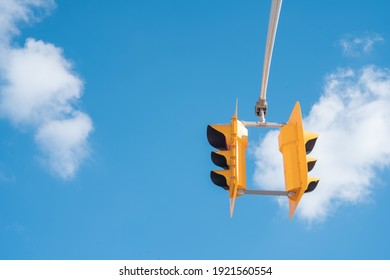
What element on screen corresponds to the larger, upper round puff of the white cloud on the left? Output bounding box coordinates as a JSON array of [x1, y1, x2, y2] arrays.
[[0, 38, 82, 124]]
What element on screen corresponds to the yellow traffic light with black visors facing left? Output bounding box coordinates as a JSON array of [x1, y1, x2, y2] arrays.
[[207, 113, 248, 216]]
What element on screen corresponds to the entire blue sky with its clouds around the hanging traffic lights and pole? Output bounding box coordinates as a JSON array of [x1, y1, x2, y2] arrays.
[[0, 0, 390, 259]]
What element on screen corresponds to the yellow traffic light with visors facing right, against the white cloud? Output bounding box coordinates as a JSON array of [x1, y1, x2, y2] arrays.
[[279, 102, 319, 219]]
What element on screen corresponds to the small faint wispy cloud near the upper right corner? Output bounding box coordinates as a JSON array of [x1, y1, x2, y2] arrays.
[[337, 34, 383, 57]]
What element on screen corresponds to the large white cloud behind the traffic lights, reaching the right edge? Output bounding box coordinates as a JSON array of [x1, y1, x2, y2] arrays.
[[254, 66, 390, 222]]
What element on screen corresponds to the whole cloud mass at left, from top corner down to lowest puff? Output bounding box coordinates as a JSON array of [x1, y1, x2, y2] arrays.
[[0, 0, 93, 179]]
